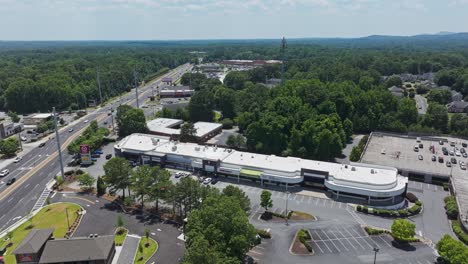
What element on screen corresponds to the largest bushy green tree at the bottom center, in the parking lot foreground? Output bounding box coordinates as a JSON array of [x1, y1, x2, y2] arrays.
[[186, 194, 256, 263]]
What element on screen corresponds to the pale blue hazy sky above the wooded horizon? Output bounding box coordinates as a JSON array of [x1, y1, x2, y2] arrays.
[[0, 0, 468, 40]]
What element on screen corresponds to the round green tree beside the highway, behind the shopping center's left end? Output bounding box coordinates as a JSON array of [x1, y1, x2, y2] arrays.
[[116, 105, 148, 137]]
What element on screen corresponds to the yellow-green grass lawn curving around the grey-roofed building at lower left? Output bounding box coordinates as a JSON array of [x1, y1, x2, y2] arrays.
[[0, 203, 81, 263]]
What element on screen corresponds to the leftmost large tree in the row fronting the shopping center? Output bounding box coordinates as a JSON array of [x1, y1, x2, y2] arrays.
[[103, 157, 132, 200]]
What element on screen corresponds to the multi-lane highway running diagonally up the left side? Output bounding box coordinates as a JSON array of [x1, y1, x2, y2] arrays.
[[0, 64, 192, 232]]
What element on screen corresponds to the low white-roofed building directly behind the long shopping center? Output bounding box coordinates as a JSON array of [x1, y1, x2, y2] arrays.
[[147, 118, 223, 142]]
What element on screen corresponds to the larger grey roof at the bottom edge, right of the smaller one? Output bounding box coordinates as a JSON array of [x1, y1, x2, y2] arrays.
[[39, 236, 114, 263]]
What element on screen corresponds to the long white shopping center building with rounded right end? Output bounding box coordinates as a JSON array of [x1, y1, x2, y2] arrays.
[[114, 134, 408, 206]]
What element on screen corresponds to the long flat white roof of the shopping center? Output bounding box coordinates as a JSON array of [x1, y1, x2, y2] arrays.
[[117, 134, 398, 188]]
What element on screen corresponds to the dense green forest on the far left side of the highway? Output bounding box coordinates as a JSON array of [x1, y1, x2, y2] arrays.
[[0, 46, 190, 114]]
